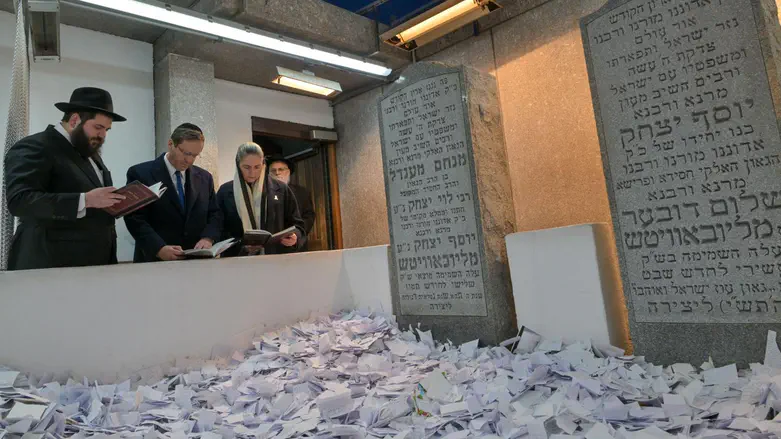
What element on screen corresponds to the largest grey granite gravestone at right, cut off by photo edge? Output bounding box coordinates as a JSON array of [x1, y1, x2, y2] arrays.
[[581, 0, 781, 364]]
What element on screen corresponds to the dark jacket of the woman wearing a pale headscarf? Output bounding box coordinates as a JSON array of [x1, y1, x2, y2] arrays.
[[217, 178, 306, 256]]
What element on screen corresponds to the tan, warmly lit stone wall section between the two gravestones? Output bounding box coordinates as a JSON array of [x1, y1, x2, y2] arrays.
[[493, 0, 610, 231]]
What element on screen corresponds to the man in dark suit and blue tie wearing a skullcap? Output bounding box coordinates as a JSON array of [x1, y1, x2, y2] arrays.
[[125, 123, 222, 262]]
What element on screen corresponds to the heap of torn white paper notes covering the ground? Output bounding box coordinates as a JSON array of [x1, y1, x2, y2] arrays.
[[0, 312, 781, 439]]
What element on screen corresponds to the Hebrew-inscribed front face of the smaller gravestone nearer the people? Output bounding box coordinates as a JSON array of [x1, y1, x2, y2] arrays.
[[380, 73, 486, 316]]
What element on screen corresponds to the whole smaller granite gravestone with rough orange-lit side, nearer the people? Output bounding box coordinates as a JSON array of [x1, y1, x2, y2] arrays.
[[379, 63, 516, 343]]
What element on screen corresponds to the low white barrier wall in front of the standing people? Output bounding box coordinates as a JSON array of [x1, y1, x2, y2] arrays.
[[0, 246, 391, 382]]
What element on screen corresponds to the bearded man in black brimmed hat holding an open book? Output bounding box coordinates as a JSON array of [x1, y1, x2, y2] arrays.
[[5, 87, 126, 270]]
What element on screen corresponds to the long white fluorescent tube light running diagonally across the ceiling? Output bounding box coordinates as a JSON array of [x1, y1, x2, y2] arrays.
[[70, 0, 392, 76]]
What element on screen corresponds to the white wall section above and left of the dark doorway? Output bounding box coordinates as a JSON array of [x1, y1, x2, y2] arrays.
[[214, 79, 334, 184]]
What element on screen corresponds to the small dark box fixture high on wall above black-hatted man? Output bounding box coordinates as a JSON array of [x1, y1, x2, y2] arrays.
[[27, 0, 60, 61]]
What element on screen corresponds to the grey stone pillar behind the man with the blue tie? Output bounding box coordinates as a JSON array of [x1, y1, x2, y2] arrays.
[[154, 54, 218, 182]]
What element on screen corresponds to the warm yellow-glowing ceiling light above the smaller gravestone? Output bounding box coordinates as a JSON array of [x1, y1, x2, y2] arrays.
[[380, 0, 500, 50]]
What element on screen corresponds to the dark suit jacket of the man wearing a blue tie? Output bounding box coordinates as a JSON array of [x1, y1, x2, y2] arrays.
[[125, 154, 222, 262]]
